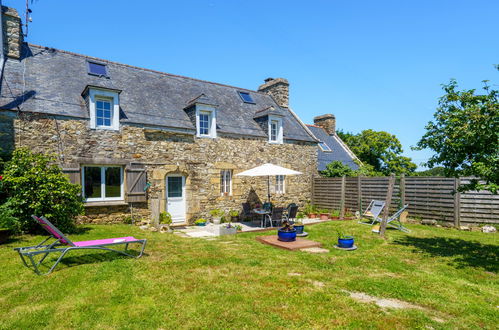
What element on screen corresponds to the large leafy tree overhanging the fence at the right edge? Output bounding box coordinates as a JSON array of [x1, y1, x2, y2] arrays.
[[415, 75, 499, 194]]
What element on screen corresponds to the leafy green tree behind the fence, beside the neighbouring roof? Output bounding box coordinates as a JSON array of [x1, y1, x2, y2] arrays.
[[337, 129, 417, 175]]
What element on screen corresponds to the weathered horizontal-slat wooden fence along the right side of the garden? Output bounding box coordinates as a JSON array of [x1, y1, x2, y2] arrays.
[[312, 176, 499, 226]]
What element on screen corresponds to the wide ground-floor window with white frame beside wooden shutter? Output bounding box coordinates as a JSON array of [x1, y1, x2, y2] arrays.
[[81, 165, 124, 202]]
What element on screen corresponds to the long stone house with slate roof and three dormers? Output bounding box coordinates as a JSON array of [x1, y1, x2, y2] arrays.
[[0, 7, 317, 224]]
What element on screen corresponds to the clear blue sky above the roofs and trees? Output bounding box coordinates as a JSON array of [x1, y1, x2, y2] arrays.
[[3, 0, 499, 164]]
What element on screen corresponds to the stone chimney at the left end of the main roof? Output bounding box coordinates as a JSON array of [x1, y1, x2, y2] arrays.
[[2, 6, 23, 59]]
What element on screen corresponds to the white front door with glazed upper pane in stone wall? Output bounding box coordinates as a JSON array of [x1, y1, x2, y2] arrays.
[[166, 175, 185, 223]]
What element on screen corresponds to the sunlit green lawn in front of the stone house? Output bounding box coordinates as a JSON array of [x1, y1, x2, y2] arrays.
[[0, 221, 499, 329]]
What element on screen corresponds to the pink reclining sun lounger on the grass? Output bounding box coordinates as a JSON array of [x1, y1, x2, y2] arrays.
[[14, 215, 147, 275]]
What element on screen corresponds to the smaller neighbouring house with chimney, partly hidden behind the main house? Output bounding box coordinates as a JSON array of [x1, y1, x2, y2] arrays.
[[307, 114, 362, 171]]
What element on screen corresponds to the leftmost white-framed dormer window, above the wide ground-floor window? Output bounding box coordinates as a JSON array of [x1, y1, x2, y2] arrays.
[[88, 88, 120, 130]]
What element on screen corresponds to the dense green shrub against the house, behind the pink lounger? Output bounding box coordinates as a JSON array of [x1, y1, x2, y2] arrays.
[[2, 148, 84, 232]]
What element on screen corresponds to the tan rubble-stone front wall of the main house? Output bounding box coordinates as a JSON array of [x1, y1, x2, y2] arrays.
[[3, 111, 317, 222]]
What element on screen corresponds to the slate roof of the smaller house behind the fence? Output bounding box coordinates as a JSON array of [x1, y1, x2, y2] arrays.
[[307, 125, 359, 171]]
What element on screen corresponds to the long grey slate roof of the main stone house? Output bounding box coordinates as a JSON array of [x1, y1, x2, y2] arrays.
[[0, 44, 315, 142]]
